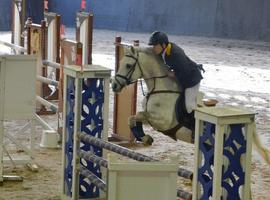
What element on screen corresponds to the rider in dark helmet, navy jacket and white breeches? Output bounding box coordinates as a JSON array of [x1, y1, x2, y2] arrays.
[[148, 31, 204, 136]]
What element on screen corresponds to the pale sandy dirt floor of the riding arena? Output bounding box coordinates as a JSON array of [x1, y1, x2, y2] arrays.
[[0, 29, 270, 200]]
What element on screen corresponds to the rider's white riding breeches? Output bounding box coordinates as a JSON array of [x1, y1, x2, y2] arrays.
[[185, 83, 200, 113]]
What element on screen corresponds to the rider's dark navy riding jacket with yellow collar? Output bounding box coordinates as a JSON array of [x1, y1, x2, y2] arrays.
[[164, 43, 203, 89]]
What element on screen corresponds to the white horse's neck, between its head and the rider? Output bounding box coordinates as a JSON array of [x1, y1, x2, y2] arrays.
[[141, 51, 180, 92]]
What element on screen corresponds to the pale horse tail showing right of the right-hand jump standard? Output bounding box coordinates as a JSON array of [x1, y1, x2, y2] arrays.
[[253, 126, 270, 165]]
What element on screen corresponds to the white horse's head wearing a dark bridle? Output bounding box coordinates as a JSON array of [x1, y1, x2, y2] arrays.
[[111, 46, 142, 92]]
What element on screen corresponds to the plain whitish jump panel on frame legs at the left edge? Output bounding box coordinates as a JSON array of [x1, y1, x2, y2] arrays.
[[0, 55, 37, 184]]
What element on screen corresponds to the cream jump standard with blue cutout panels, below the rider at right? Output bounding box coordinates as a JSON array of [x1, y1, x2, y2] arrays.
[[193, 107, 255, 200]]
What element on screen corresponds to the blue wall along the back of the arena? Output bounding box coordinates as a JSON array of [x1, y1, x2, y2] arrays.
[[0, 0, 270, 41]]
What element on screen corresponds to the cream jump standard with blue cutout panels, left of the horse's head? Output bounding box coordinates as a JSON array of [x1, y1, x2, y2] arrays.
[[61, 65, 111, 200]]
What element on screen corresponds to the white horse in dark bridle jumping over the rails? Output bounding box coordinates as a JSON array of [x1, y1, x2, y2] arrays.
[[112, 46, 270, 165]]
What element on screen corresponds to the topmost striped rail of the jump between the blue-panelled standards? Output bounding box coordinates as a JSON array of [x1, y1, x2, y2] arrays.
[[78, 133, 193, 180]]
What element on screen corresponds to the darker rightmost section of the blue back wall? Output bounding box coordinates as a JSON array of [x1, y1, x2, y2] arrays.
[[214, 0, 270, 41]]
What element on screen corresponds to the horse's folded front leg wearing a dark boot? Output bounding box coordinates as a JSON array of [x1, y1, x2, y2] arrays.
[[129, 112, 154, 145]]
